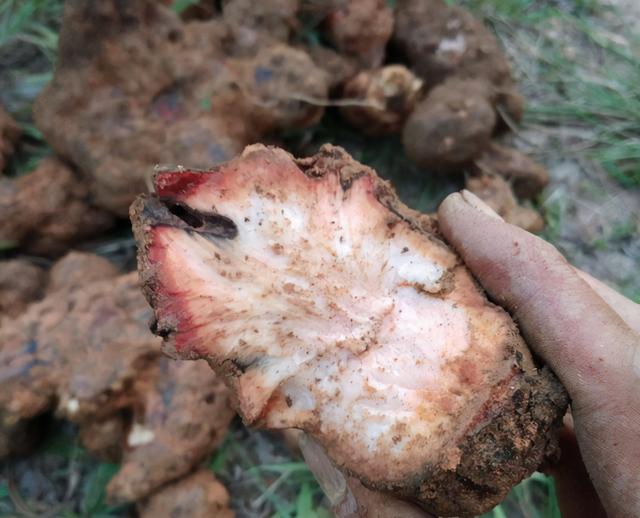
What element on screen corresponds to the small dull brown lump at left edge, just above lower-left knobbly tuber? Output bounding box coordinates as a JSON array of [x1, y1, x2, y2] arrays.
[[0, 259, 47, 318]]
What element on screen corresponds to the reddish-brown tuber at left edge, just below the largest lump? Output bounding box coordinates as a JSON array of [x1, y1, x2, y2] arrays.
[[0, 158, 113, 256]]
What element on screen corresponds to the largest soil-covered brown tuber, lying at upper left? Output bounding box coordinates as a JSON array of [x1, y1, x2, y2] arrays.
[[35, 0, 327, 215]]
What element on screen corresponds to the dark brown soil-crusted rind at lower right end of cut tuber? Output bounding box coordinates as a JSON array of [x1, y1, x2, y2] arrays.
[[363, 366, 569, 518]]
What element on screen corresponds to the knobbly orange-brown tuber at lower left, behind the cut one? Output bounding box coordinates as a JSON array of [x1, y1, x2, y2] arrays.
[[0, 272, 233, 500]]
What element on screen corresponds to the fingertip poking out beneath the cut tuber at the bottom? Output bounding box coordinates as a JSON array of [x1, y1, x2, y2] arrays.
[[299, 434, 432, 518]]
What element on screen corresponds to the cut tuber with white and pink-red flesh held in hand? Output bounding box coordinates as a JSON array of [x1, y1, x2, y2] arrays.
[[131, 145, 567, 516]]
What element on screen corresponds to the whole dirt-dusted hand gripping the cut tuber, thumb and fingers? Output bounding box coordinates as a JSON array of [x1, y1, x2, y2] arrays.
[[301, 191, 640, 518]]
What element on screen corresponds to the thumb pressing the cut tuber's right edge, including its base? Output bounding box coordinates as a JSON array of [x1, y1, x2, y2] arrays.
[[438, 191, 640, 516]]
